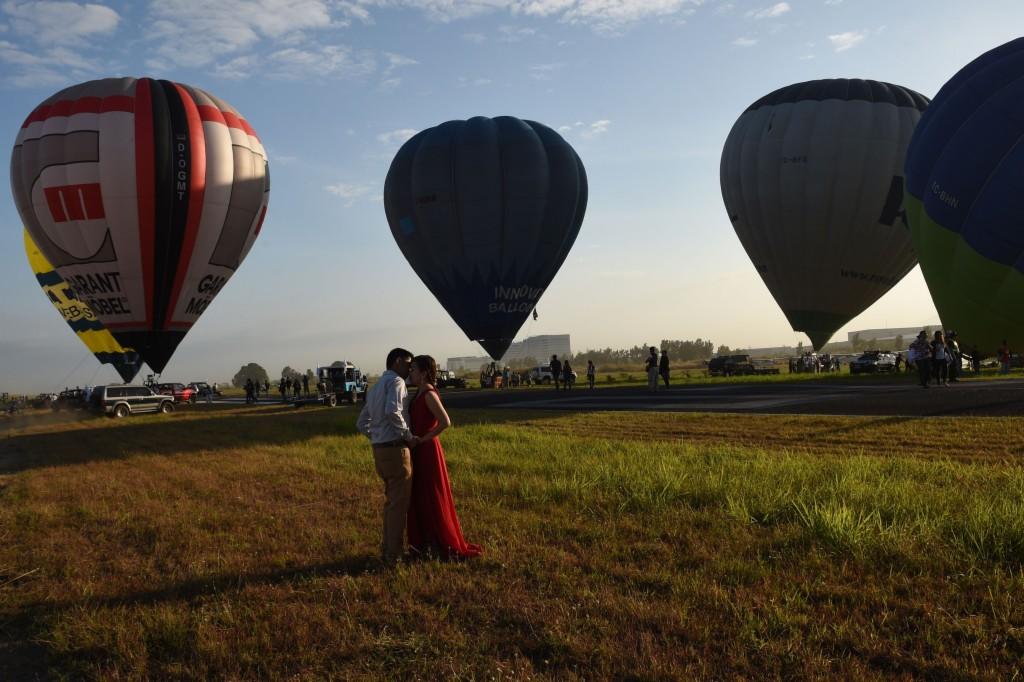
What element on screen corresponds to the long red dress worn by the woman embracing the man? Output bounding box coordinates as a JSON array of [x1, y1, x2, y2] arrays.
[[408, 388, 482, 558]]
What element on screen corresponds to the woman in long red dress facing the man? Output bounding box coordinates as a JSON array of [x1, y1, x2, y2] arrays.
[[408, 355, 481, 559]]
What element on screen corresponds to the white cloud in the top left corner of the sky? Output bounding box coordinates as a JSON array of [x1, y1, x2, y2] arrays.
[[3, 1, 121, 45]]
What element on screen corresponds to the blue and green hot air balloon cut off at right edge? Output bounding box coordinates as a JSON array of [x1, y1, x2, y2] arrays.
[[906, 38, 1024, 353]]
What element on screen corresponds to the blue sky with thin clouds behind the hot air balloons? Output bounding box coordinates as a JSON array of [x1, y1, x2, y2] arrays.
[[0, 0, 1024, 392]]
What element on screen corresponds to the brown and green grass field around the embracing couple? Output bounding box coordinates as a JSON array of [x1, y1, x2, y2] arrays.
[[0, 406, 1024, 680]]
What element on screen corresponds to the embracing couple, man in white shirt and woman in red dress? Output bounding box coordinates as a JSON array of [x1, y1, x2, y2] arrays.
[[356, 348, 481, 566]]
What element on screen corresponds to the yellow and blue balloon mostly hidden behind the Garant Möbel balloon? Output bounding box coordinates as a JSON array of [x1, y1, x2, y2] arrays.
[[23, 229, 141, 383]]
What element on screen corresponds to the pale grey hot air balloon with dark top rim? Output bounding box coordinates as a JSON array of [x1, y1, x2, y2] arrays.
[[721, 79, 928, 348]]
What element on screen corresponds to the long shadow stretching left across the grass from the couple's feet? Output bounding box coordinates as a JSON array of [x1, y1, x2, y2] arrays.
[[0, 555, 387, 680]]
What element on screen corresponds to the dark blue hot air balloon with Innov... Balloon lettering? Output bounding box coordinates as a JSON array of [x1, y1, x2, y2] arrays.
[[384, 116, 587, 359]]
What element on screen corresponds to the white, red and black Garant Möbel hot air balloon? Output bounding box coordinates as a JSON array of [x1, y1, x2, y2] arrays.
[[10, 78, 269, 373]]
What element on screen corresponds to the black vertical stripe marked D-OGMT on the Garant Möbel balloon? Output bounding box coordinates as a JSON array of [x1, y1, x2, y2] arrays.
[[152, 81, 191, 330]]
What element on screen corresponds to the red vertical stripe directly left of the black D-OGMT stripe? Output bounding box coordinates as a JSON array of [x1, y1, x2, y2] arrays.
[[135, 78, 157, 329]]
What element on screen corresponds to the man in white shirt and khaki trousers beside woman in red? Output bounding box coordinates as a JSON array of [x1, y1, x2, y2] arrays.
[[355, 348, 420, 566]]
